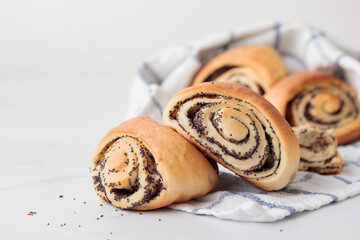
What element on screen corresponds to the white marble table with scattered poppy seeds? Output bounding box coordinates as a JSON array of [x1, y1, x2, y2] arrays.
[[0, 76, 360, 240]]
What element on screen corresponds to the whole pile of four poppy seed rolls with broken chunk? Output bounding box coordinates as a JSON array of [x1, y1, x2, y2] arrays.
[[90, 45, 360, 210]]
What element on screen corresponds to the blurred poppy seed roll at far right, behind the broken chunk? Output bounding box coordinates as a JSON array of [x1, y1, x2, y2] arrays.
[[264, 71, 360, 144]]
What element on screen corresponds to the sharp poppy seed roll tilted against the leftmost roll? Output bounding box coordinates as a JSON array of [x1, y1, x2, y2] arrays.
[[163, 83, 300, 190]]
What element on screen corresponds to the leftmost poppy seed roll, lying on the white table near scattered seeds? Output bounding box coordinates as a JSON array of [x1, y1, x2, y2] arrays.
[[90, 117, 219, 210]]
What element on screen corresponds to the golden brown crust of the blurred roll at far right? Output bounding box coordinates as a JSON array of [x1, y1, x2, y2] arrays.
[[264, 71, 360, 145]]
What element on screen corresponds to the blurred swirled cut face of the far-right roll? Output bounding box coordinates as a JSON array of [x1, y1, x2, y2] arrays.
[[286, 83, 359, 129]]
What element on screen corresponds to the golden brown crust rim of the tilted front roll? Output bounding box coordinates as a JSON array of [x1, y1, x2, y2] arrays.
[[163, 83, 300, 190]]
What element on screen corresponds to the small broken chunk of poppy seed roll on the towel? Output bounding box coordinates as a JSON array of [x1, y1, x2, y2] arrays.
[[293, 125, 343, 174]]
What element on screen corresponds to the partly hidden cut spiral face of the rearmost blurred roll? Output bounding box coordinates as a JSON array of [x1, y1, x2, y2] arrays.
[[204, 65, 265, 95]]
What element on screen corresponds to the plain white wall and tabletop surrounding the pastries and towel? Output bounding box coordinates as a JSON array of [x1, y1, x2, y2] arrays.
[[0, 0, 360, 239]]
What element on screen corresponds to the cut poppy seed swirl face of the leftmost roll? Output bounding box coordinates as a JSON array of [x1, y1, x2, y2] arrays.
[[92, 134, 163, 209]]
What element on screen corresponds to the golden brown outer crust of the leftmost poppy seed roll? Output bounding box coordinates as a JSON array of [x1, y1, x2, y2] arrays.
[[90, 117, 219, 210]]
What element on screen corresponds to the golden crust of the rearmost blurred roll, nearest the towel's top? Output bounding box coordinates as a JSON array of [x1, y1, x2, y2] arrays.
[[192, 45, 287, 90]]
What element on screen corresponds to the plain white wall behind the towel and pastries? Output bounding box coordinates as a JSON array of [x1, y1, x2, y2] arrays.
[[0, 0, 360, 78]]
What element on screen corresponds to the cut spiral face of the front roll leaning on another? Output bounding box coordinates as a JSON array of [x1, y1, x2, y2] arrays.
[[169, 92, 281, 178]]
